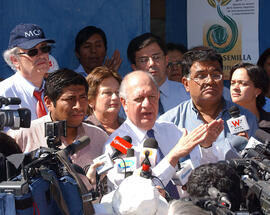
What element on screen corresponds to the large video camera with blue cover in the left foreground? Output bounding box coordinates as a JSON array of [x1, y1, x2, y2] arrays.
[[0, 121, 95, 215]]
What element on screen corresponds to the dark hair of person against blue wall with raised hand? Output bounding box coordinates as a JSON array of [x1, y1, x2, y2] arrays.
[[75, 26, 107, 53]]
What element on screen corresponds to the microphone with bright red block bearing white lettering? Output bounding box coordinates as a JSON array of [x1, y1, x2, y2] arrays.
[[110, 136, 132, 159]]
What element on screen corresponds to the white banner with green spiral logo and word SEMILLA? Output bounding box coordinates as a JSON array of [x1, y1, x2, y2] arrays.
[[187, 0, 259, 79]]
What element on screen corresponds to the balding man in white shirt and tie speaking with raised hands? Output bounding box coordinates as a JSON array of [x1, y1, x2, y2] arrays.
[[105, 71, 223, 198]]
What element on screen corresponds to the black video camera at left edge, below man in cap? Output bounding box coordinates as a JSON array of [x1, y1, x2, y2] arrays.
[[0, 96, 31, 130]]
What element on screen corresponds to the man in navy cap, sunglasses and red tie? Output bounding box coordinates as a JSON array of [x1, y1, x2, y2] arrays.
[[0, 24, 55, 120]]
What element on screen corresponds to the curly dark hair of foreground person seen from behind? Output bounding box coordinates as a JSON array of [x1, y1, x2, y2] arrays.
[[187, 161, 241, 210]]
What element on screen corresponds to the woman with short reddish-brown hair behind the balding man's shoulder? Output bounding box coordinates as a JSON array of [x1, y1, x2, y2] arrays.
[[85, 66, 124, 135]]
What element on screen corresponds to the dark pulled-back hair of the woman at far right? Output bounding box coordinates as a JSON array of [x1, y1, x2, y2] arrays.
[[230, 62, 269, 109]]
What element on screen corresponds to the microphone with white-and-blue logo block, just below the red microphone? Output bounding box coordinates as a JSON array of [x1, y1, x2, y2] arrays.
[[117, 148, 137, 178]]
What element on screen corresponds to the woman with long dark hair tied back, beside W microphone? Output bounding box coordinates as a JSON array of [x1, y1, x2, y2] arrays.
[[230, 63, 270, 133]]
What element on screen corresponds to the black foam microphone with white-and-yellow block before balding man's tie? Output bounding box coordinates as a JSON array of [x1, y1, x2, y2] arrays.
[[140, 138, 158, 167]]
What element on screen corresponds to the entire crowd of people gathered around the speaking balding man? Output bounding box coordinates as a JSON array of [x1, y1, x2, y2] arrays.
[[0, 24, 270, 215]]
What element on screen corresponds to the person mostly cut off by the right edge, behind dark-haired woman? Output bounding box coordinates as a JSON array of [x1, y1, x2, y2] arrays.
[[257, 48, 270, 112]]
